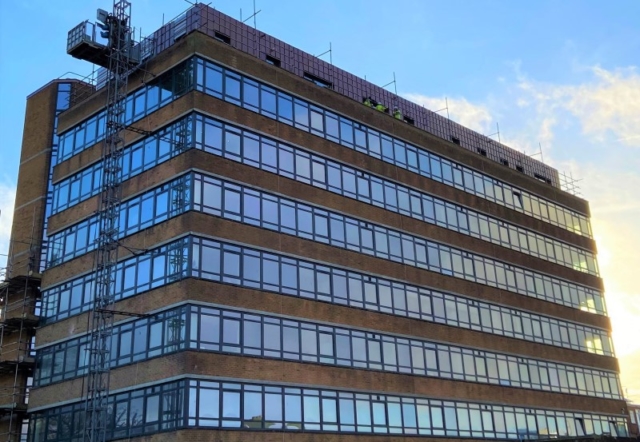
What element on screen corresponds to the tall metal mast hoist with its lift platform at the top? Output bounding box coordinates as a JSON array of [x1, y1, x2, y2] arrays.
[[67, 0, 142, 442]]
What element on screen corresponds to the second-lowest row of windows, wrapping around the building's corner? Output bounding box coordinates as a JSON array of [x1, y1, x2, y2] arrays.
[[35, 306, 620, 402]]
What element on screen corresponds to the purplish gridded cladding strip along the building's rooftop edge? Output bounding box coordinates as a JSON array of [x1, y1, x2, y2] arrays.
[[94, 3, 560, 188]]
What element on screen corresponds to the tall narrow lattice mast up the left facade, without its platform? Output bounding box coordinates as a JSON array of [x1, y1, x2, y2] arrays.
[[85, 0, 131, 442]]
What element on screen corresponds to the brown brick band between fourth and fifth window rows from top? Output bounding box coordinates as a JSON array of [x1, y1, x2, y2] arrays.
[[38, 270, 618, 371]]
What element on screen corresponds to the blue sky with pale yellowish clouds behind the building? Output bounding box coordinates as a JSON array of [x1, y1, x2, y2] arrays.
[[0, 0, 640, 403]]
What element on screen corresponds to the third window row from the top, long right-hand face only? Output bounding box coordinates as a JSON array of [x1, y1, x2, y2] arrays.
[[195, 175, 600, 314]]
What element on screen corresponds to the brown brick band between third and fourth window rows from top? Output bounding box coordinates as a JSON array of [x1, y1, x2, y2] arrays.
[[42, 212, 609, 340]]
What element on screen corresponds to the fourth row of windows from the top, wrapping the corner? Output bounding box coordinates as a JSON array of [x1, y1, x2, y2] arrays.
[[44, 228, 618, 370]]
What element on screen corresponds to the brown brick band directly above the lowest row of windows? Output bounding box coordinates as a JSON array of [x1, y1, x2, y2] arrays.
[[29, 351, 624, 413]]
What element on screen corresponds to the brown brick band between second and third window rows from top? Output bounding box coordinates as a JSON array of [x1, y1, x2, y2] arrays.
[[49, 149, 602, 290]]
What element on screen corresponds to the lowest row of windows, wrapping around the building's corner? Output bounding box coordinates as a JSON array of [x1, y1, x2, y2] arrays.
[[29, 380, 627, 442]]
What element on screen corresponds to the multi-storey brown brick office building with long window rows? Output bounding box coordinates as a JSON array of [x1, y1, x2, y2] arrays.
[[1, 4, 629, 442]]
